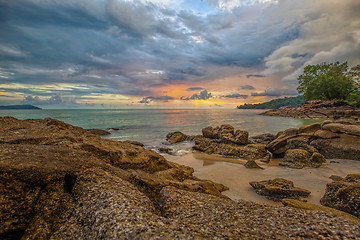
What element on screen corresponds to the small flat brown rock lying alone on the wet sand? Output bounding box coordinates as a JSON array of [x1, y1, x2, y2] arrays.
[[249, 178, 311, 201]]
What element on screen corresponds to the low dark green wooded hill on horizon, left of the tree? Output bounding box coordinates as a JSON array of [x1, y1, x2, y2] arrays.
[[237, 96, 305, 109]]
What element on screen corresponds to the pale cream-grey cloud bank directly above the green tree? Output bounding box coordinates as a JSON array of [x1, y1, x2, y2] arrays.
[[263, 0, 360, 83]]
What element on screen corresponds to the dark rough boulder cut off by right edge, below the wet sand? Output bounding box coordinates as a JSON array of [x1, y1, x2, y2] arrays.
[[320, 174, 360, 218]]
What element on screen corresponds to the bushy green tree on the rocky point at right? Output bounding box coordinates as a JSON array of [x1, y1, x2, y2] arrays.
[[297, 62, 360, 100]]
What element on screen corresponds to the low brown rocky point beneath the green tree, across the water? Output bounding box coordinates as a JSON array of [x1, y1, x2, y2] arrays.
[[261, 100, 360, 120]]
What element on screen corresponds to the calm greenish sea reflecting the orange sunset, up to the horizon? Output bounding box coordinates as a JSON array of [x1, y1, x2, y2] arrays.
[[0, 109, 320, 148]]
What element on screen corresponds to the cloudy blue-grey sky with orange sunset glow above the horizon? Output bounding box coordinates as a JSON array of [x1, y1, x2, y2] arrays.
[[0, 0, 360, 108]]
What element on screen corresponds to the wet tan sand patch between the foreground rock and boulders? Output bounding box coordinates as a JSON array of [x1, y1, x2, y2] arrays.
[[165, 152, 360, 205]]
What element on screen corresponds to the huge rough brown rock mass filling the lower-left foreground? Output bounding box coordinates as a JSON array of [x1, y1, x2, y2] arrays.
[[0, 117, 360, 239]]
